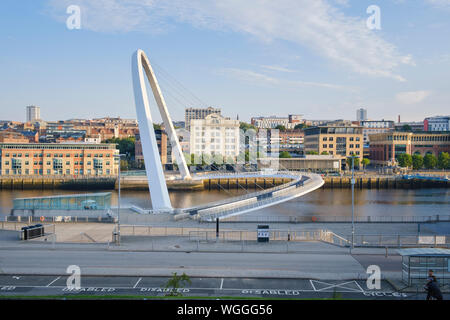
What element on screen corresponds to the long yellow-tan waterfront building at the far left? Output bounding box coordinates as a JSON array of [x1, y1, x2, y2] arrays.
[[0, 143, 119, 176]]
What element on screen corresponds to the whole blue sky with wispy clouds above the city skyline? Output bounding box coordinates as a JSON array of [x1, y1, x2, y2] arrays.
[[0, 0, 450, 121]]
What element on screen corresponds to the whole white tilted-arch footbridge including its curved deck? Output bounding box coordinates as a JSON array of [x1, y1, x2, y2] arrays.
[[131, 50, 324, 220]]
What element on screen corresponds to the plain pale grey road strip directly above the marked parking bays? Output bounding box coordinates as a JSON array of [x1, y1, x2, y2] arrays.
[[0, 248, 365, 280]]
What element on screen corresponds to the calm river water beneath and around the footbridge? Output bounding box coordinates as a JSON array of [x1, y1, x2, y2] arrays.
[[0, 189, 450, 216]]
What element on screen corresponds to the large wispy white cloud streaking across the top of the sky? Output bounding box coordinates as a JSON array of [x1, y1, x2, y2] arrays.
[[49, 0, 413, 81]]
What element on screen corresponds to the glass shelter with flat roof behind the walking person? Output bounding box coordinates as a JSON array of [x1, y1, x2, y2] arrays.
[[398, 248, 450, 286]]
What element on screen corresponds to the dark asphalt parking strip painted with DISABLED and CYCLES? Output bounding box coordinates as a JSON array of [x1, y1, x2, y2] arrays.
[[0, 274, 436, 300]]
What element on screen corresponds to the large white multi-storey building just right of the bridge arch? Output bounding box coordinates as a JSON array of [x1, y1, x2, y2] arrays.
[[190, 114, 239, 157]]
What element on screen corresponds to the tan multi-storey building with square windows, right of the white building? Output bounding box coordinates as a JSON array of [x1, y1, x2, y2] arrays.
[[304, 126, 363, 159]]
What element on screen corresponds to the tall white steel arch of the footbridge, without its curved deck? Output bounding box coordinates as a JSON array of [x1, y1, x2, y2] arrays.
[[131, 49, 191, 211]]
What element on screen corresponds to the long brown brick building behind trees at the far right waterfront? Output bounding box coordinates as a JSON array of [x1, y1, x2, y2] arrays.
[[369, 131, 450, 165]]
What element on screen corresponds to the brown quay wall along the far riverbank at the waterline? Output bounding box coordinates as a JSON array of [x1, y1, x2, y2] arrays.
[[0, 173, 450, 191]]
